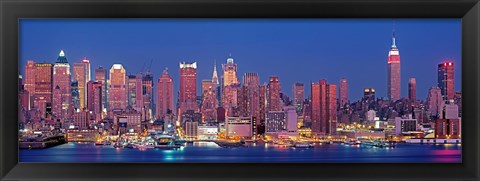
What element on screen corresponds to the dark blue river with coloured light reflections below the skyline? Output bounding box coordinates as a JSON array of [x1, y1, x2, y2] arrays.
[[19, 142, 462, 163]]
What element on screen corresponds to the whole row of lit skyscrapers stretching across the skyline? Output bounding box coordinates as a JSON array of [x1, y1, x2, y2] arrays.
[[20, 29, 461, 139]]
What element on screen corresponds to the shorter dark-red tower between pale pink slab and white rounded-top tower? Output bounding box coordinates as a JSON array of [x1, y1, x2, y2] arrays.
[[87, 81, 102, 122]]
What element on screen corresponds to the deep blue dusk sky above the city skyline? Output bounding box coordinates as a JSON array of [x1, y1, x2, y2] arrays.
[[20, 19, 461, 101]]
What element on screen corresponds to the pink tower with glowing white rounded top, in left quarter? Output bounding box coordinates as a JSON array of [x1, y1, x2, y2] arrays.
[[108, 64, 127, 111]]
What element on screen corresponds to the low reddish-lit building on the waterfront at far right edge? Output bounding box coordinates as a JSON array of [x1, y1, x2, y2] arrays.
[[435, 119, 461, 139]]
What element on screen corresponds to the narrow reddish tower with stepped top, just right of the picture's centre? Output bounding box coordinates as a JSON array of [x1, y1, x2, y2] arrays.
[[267, 76, 283, 111]]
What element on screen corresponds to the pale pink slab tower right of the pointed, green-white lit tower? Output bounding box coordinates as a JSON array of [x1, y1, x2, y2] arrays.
[[73, 57, 90, 109]]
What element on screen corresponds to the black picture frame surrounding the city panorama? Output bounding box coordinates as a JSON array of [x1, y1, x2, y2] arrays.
[[0, 0, 480, 180]]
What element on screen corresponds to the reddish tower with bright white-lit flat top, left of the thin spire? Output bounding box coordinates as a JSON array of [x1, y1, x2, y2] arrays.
[[178, 62, 198, 115]]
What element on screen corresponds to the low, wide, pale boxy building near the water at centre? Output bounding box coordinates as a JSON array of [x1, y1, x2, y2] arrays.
[[225, 117, 253, 139]]
